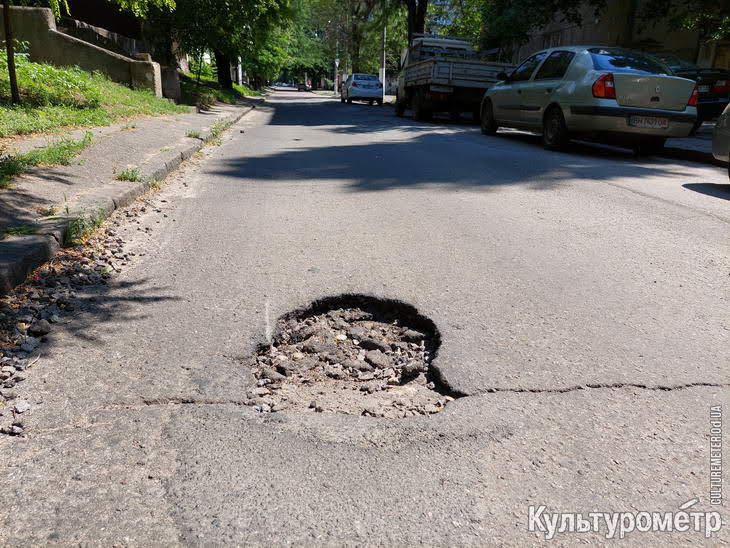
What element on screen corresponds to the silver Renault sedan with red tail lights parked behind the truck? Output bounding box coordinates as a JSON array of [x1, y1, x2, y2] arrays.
[[481, 46, 698, 153]]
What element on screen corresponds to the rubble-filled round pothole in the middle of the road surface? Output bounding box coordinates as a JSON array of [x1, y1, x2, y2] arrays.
[[247, 295, 454, 418]]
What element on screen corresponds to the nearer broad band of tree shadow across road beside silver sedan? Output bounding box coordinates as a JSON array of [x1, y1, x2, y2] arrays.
[[214, 124, 691, 192]]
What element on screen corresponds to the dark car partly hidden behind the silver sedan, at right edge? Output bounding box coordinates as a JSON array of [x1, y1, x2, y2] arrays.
[[653, 53, 730, 124]]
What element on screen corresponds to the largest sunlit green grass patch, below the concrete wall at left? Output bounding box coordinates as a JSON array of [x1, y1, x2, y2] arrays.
[[0, 53, 190, 137]]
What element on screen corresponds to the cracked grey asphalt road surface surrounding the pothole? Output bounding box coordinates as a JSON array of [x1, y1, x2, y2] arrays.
[[0, 92, 730, 545]]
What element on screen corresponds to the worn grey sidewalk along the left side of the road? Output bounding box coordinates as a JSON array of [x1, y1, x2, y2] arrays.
[[0, 99, 262, 295]]
